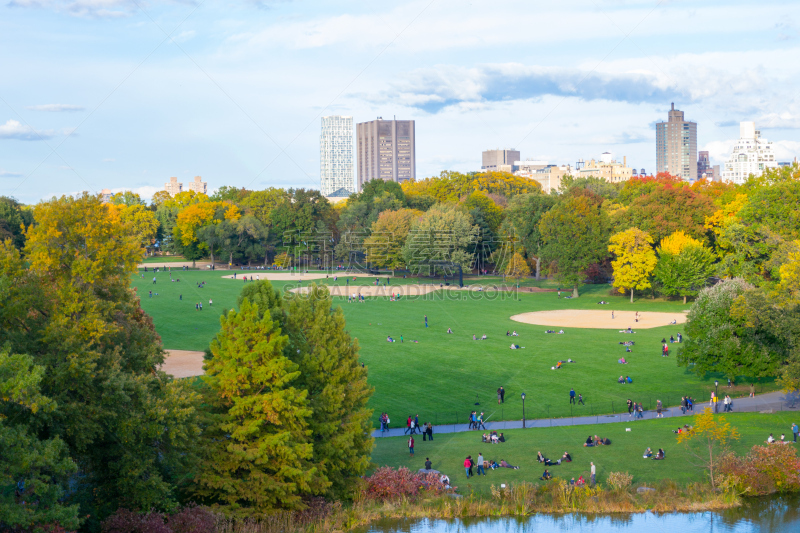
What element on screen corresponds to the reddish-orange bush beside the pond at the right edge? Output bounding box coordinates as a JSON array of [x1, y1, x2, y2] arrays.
[[719, 444, 800, 496]]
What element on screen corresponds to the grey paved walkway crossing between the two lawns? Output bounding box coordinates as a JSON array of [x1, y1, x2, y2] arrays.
[[372, 391, 800, 438]]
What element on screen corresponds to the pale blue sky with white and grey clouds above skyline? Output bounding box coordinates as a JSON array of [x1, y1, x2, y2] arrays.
[[0, 0, 800, 202]]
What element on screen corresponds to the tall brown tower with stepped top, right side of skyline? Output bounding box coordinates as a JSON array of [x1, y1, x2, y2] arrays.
[[656, 104, 697, 181]]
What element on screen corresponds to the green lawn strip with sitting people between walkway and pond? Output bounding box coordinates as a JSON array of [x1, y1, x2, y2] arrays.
[[372, 413, 800, 492]]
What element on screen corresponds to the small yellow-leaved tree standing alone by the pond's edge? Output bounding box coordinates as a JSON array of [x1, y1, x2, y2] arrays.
[[678, 407, 739, 487]]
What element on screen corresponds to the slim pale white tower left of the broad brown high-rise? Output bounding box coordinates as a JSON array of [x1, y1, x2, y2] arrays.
[[319, 115, 355, 196]]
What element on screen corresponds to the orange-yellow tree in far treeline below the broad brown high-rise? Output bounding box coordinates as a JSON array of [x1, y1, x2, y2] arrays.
[[364, 209, 422, 270]]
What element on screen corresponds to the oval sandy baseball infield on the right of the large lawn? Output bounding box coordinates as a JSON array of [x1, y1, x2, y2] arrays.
[[511, 309, 686, 331]]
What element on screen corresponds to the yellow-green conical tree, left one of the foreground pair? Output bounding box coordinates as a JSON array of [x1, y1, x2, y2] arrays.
[[192, 298, 318, 515]]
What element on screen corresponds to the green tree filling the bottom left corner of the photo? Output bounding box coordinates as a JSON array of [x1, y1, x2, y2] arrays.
[[0, 349, 80, 530]]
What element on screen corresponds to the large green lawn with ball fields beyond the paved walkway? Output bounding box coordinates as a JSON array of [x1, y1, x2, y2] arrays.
[[133, 269, 780, 427]]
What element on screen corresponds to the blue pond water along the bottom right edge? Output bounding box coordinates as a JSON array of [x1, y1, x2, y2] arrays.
[[359, 496, 800, 533]]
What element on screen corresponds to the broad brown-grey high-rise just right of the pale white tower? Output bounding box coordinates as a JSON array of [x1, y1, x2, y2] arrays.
[[356, 117, 417, 190]]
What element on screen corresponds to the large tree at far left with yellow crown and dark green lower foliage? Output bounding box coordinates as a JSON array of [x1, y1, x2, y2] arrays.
[[0, 194, 197, 520]]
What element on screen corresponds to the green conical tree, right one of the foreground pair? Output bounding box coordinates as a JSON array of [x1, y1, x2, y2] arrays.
[[286, 285, 373, 498]]
